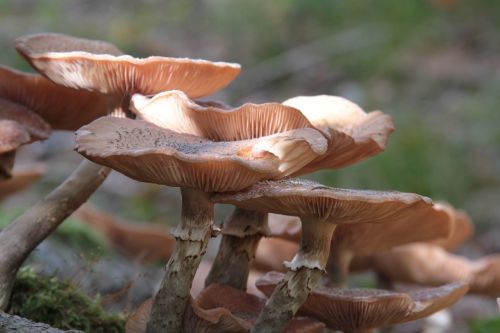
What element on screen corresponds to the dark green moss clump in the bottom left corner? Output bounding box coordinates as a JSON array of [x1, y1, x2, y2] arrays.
[[9, 267, 125, 333]]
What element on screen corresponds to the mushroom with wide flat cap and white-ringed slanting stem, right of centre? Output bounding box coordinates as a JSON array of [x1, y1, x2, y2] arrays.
[[213, 179, 444, 332]]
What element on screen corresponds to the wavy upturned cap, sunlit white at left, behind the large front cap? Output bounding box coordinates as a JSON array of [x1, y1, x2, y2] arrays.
[[131, 90, 313, 141]]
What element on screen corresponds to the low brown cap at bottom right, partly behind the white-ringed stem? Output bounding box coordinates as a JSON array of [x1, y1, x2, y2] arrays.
[[256, 272, 468, 333]]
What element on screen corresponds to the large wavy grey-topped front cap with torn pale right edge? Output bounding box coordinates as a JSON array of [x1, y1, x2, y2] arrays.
[[76, 117, 326, 192]]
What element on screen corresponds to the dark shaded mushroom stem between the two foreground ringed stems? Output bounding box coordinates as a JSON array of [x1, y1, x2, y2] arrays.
[[205, 207, 269, 290]]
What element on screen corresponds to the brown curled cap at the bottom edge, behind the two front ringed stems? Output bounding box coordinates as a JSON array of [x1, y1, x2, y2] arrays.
[[125, 284, 325, 333]]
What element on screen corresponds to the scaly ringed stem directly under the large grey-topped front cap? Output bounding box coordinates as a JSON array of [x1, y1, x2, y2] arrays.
[[147, 188, 214, 333]]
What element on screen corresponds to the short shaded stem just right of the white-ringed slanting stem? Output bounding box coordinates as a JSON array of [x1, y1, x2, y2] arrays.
[[324, 244, 354, 288]]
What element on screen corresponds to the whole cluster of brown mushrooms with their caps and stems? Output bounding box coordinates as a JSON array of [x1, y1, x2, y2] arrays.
[[0, 34, 494, 333]]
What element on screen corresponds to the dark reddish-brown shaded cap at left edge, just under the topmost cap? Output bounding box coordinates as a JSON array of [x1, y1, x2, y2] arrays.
[[0, 66, 108, 131]]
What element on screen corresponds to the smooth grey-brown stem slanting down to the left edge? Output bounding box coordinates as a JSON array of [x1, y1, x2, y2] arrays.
[[0, 160, 110, 310]]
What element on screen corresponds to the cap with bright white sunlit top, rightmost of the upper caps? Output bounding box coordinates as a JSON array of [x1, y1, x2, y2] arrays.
[[283, 95, 394, 176]]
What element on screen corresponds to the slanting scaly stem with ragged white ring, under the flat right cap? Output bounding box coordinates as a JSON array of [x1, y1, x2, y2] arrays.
[[250, 218, 335, 333]]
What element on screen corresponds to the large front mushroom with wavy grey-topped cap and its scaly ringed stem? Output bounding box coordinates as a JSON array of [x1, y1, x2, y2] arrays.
[[76, 113, 326, 331]]
